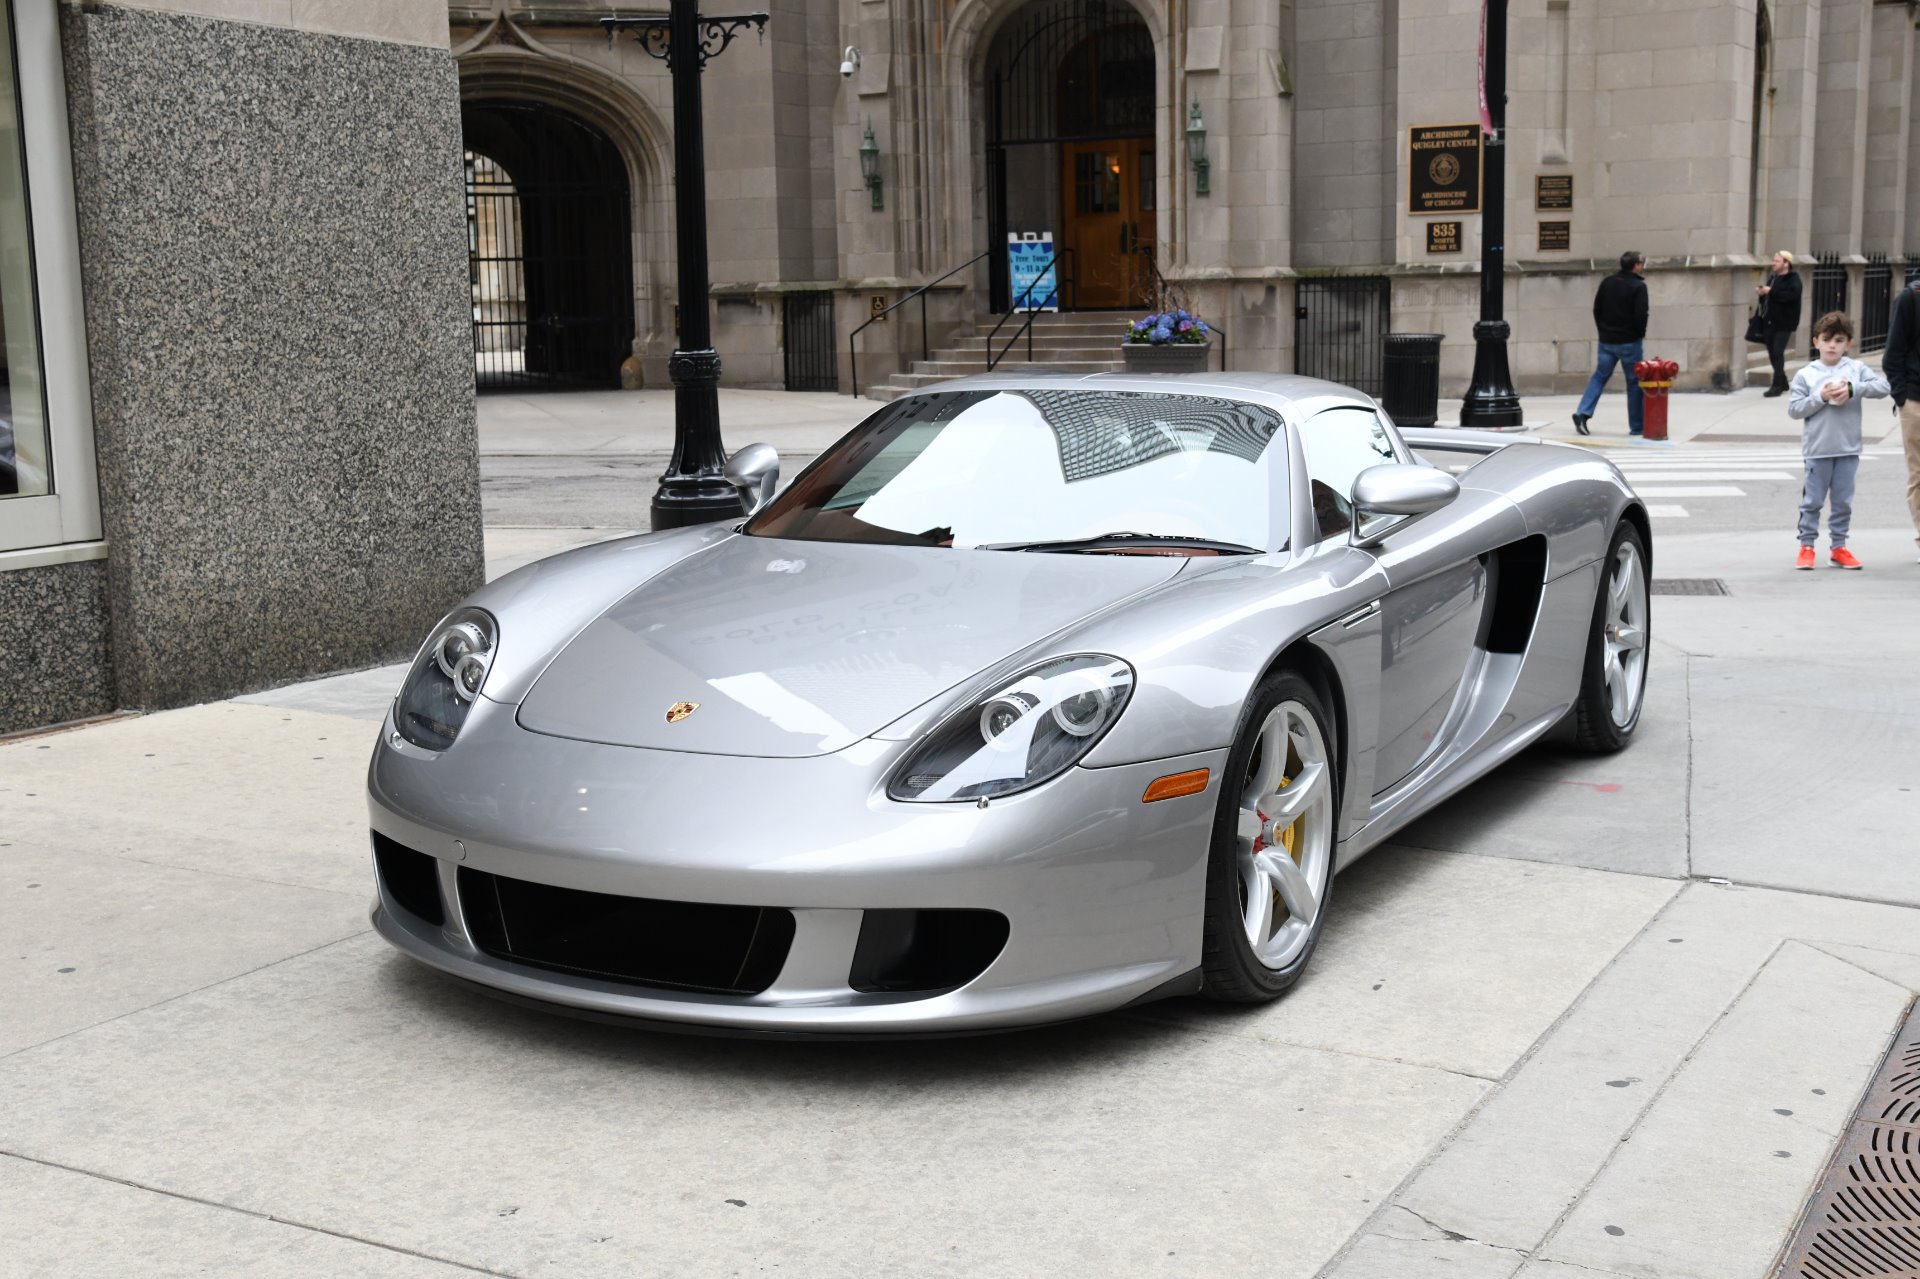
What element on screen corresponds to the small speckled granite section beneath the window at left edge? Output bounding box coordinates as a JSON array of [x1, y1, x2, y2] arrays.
[[0, 559, 113, 734]]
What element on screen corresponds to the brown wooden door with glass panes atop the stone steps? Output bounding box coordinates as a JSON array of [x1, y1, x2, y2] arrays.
[[1060, 138, 1158, 309]]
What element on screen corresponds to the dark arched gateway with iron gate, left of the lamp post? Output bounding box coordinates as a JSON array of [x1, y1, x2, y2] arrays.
[[461, 100, 634, 390]]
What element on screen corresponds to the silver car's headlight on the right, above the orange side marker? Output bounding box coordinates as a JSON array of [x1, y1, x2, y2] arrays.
[[887, 653, 1133, 803]]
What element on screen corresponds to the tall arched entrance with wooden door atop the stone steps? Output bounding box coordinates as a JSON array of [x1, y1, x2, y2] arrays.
[[987, 0, 1160, 311]]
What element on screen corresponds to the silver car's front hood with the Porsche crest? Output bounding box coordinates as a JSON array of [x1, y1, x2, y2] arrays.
[[518, 536, 1187, 757]]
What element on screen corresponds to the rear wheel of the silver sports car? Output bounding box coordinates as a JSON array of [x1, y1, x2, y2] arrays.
[[1574, 520, 1653, 755]]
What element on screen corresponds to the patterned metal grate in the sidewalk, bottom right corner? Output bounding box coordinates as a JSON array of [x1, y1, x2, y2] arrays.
[[1774, 1002, 1920, 1279]]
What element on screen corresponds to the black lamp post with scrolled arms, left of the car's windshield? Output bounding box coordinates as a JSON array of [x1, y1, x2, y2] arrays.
[[601, 0, 766, 528]]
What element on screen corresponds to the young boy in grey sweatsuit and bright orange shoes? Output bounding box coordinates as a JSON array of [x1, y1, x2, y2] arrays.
[[1788, 311, 1887, 568]]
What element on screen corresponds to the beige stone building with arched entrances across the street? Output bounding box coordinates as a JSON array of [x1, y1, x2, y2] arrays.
[[449, 0, 1920, 395]]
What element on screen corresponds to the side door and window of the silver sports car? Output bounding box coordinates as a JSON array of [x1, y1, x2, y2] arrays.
[[1300, 407, 1490, 793]]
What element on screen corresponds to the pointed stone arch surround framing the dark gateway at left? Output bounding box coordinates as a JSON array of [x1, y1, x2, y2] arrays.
[[453, 39, 674, 382]]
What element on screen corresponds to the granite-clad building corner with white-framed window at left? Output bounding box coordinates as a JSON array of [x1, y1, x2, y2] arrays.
[[0, 0, 482, 734]]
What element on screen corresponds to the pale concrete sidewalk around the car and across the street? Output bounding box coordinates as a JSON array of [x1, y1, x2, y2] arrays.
[[0, 380, 1920, 1279]]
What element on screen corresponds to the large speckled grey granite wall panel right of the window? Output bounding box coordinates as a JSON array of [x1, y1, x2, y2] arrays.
[[61, 4, 482, 707]]
